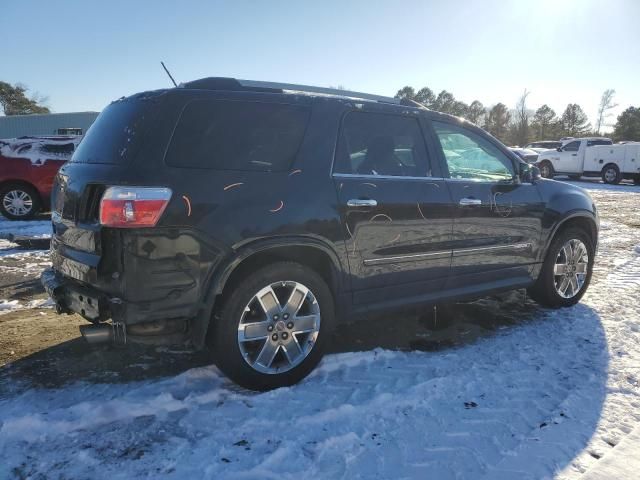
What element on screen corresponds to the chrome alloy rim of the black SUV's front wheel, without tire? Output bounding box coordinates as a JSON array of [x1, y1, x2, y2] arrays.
[[553, 238, 589, 298]]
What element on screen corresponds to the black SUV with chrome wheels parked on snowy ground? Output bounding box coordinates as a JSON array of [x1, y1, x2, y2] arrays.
[[43, 78, 598, 389]]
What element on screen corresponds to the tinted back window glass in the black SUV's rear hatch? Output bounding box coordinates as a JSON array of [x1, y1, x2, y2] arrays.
[[71, 99, 157, 164]]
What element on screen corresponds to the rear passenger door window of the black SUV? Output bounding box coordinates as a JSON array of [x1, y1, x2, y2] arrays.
[[334, 112, 431, 177]]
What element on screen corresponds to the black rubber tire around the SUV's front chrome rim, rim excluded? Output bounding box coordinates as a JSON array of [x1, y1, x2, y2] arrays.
[[528, 228, 595, 308]]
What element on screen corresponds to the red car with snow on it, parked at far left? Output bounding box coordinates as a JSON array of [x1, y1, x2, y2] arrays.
[[0, 136, 80, 220]]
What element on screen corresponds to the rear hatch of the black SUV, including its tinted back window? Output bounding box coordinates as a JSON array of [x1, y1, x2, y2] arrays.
[[51, 91, 166, 286]]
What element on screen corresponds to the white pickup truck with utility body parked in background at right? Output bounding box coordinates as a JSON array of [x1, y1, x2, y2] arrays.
[[537, 137, 640, 185]]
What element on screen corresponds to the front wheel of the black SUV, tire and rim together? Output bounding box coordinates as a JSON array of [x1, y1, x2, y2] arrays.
[[528, 228, 595, 308]]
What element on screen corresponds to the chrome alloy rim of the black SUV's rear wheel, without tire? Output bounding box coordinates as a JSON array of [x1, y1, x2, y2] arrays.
[[238, 281, 320, 374]]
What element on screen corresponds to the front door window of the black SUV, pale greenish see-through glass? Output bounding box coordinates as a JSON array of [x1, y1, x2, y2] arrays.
[[432, 122, 515, 182]]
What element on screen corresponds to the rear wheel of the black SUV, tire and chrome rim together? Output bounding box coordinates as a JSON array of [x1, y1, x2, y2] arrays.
[[208, 262, 335, 390]]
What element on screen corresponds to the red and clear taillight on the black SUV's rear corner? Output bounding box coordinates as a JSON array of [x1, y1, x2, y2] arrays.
[[100, 187, 171, 228]]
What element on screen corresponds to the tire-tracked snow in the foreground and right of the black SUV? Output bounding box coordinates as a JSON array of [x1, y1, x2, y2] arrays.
[[0, 182, 640, 479]]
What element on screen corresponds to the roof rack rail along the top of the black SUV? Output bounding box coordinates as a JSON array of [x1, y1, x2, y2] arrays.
[[180, 77, 401, 105]]
